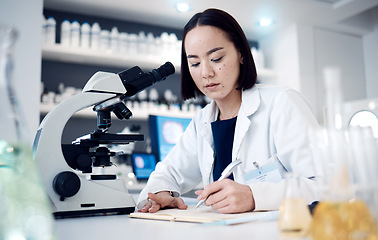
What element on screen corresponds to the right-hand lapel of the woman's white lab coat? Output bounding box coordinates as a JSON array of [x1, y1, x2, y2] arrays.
[[232, 87, 260, 160]]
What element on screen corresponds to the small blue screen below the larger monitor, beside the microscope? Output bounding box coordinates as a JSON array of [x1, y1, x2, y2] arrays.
[[131, 153, 157, 180]]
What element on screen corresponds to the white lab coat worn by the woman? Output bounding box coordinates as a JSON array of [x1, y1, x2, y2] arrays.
[[137, 84, 319, 210]]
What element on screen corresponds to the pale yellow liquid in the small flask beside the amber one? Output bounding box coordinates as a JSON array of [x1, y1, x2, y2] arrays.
[[278, 198, 311, 238]]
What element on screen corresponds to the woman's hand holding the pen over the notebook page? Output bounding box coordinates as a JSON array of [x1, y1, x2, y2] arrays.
[[195, 179, 255, 213]]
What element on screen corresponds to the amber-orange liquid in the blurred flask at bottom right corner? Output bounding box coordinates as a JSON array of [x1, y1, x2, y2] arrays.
[[310, 200, 378, 240]]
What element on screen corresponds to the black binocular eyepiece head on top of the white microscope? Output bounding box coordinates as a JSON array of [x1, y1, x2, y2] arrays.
[[118, 62, 175, 98]]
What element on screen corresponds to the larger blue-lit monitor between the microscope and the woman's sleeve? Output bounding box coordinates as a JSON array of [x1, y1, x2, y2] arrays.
[[149, 115, 191, 161]]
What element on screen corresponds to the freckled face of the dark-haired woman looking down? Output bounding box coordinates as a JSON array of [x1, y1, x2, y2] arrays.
[[185, 26, 242, 101]]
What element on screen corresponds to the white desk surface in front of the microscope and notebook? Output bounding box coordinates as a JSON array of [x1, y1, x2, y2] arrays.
[[56, 196, 280, 240]]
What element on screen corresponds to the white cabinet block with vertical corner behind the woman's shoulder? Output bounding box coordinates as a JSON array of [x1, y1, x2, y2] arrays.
[[259, 24, 321, 120]]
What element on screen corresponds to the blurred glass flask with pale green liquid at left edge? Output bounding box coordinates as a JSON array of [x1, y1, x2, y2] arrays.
[[0, 25, 55, 240]]
